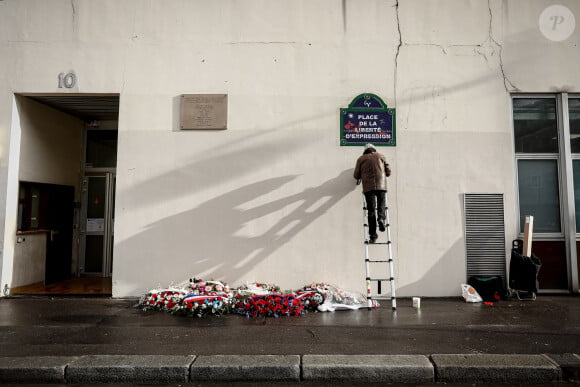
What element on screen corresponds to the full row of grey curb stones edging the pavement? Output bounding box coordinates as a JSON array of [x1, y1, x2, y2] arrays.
[[0, 353, 580, 385]]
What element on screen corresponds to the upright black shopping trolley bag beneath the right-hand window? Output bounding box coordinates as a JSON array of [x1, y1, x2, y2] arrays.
[[509, 240, 542, 294]]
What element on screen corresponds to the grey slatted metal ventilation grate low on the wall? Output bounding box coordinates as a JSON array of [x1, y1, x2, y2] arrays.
[[463, 193, 506, 283]]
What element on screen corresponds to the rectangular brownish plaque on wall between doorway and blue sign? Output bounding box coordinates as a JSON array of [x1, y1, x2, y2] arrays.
[[179, 94, 228, 129]]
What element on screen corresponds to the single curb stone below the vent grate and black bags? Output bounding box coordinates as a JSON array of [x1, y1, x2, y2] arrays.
[[431, 354, 562, 383]]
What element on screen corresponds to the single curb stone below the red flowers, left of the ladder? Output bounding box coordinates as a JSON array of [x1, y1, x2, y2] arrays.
[[190, 355, 300, 381]]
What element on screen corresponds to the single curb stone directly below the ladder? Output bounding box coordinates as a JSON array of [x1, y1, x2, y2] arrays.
[[302, 355, 435, 383]]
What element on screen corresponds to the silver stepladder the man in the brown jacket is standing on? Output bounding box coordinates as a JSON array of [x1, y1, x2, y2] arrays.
[[363, 192, 397, 310]]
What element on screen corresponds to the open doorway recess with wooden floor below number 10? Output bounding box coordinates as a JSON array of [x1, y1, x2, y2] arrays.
[[10, 94, 119, 296]]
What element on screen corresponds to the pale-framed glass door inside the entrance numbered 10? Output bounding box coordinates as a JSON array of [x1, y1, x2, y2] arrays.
[[79, 172, 115, 277]]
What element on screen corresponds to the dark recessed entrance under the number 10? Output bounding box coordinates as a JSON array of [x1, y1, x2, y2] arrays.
[[10, 94, 119, 296]]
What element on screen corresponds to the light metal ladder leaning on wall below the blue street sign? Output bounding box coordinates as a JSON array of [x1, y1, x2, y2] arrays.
[[363, 192, 397, 310]]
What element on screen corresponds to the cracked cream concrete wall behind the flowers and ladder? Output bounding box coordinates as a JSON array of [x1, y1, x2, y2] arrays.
[[0, 0, 580, 296]]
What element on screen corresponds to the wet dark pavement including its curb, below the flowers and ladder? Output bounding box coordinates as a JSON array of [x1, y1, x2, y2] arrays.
[[0, 296, 580, 384]]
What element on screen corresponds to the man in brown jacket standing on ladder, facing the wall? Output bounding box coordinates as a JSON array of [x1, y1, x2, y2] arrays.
[[354, 144, 391, 243]]
